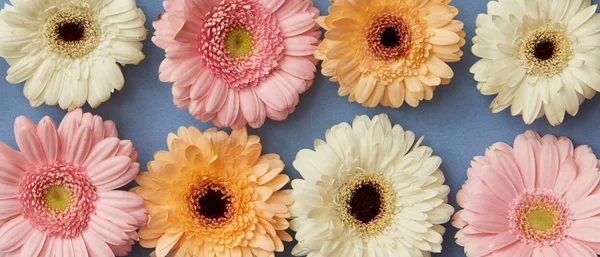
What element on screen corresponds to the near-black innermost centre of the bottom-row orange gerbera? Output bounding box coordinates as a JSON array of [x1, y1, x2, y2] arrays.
[[196, 189, 231, 219]]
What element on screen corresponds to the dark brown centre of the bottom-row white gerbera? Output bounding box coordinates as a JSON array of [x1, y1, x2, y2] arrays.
[[349, 183, 382, 223]]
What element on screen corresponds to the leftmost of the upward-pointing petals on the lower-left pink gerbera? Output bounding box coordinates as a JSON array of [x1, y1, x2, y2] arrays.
[[15, 116, 48, 166]]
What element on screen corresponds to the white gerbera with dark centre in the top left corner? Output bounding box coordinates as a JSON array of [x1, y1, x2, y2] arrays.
[[0, 0, 147, 109]]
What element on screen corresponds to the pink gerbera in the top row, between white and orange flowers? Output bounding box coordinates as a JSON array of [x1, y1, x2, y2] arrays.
[[152, 0, 321, 128]]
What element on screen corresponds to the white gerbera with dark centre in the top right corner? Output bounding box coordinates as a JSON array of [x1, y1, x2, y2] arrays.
[[471, 0, 600, 125]]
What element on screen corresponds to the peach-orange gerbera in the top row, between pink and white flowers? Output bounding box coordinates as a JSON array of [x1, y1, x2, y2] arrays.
[[315, 0, 465, 108]]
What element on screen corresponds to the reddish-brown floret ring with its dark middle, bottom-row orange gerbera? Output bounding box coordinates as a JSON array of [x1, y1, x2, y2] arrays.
[[184, 180, 236, 229]]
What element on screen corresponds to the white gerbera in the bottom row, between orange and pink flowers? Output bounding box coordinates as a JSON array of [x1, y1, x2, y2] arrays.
[[290, 114, 454, 257]]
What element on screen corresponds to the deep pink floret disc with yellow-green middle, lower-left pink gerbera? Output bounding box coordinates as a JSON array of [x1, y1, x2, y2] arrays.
[[19, 162, 97, 238]]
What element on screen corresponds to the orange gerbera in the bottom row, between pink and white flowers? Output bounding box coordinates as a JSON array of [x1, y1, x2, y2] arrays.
[[132, 127, 293, 257]]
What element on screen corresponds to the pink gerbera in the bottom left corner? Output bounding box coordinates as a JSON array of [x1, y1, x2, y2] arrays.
[[0, 109, 147, 257]]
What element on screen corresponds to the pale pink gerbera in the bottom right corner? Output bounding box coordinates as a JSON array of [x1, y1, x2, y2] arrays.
[[452, 131, 600, 257]]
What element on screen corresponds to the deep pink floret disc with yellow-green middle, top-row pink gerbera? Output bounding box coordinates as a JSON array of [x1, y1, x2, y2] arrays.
[[199, 0, 284, 89]]
